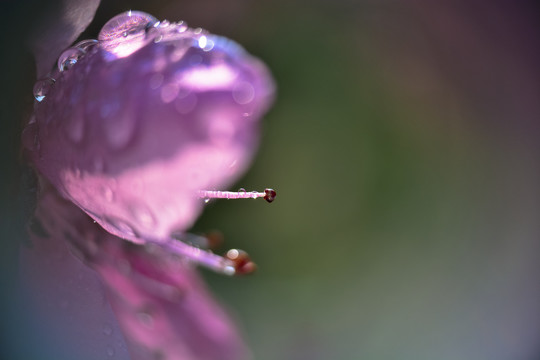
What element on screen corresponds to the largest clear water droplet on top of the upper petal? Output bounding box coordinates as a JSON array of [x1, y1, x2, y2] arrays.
[[98, 10, 158, 41]]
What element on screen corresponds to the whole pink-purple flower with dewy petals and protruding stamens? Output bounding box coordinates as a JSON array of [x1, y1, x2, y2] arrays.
[[21, 6, 273, 359]]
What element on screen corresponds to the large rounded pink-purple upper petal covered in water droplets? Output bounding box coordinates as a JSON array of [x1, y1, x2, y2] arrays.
[[25, 12, 274, 243]]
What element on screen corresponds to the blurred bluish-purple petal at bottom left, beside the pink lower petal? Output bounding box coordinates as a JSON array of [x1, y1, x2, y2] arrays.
[[20, 184, 129, 359]]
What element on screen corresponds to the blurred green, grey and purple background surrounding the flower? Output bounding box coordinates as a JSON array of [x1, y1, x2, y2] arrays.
[[0, 0, 540, 360]]
